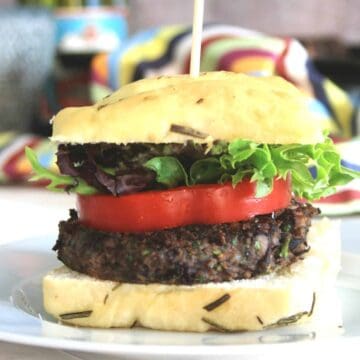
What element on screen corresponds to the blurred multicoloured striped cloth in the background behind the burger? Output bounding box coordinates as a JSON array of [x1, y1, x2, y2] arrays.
[[0, 24, 360, 214]]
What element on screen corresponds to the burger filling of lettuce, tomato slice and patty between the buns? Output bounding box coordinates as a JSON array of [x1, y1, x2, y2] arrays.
[[27, 133, 359, 284]]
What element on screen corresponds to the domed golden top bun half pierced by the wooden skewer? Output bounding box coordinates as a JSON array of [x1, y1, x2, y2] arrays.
[[52, 72, 323, 144]]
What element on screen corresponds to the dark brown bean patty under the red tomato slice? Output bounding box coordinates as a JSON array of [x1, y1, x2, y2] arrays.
[[54, 201, 319, 284]]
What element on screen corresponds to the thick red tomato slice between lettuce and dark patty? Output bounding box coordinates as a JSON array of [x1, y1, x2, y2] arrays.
[[77, 179, 291, 232]]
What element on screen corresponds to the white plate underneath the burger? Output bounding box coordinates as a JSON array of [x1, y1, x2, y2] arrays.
[[0, 236, 360, 359]]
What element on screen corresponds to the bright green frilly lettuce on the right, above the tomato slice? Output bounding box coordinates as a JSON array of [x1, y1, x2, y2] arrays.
[[145, 138, 360, 200]]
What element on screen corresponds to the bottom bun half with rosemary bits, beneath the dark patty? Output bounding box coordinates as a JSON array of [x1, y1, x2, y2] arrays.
[[43, 220, 340, 332]]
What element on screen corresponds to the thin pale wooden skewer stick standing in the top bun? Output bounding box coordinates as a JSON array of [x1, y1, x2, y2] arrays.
[[190, 0, 205, 77]]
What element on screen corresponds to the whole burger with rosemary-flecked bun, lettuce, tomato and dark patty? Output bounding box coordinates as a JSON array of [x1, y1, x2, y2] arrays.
[[27, 72, 359, 332]]
